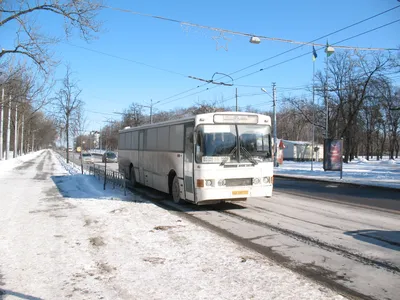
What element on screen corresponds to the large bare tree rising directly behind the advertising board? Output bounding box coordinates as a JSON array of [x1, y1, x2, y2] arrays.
[[317, 51, 393, 162]]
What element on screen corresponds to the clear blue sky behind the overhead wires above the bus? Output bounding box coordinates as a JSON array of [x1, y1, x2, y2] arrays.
[[4, 0, 400, 130]]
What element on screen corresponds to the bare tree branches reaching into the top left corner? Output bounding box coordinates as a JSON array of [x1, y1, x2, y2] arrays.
[[0, 0, 102, 71]]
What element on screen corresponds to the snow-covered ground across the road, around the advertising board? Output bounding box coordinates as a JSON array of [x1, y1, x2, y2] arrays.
[[274, 158, 400, 189]]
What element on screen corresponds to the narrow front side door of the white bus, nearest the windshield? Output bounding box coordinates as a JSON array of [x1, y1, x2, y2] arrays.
[[183, 124, 194, 201]]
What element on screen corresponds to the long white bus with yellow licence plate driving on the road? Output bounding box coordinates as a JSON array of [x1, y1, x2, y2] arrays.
[[118, 112, 273, 204]]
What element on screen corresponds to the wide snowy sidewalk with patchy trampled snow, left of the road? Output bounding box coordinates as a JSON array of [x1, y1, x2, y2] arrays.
[[0, 151, 343, 299]]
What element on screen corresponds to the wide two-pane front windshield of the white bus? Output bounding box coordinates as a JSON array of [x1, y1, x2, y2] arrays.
[[195, 124, 272, 164]]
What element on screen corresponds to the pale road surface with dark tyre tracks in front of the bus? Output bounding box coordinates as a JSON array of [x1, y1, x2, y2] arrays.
[[155, 188, 400, 300]]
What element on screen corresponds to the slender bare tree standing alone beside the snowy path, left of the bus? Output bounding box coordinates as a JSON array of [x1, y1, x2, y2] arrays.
[[54, 66, 83, 163]]
